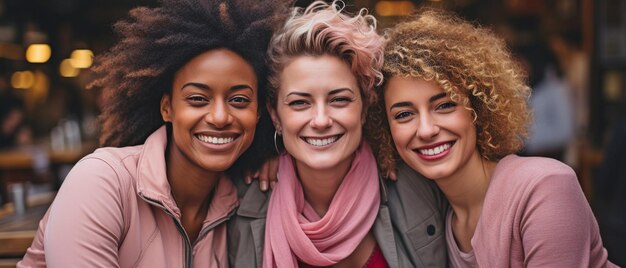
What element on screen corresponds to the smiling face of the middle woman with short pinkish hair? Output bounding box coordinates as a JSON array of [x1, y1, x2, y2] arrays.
[[270, 55, 363, 172]]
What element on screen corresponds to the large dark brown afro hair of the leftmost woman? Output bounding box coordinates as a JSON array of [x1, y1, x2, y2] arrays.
[[89, 0, 291, 174]]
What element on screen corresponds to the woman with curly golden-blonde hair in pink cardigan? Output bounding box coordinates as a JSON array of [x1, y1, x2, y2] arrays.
[[368, 10, 613, 267]]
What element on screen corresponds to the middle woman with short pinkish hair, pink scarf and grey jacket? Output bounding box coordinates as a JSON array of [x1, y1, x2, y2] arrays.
[[229, 1, 446, 267]]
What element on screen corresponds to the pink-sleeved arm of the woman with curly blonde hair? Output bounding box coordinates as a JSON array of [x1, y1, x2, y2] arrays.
[[520, 169, 599, 267]]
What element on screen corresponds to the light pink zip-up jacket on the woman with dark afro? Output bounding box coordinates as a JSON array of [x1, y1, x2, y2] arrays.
[[17, 127, 238, 267]]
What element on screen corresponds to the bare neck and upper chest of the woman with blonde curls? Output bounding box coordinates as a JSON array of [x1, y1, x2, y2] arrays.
[[436, 152, 497, 220]]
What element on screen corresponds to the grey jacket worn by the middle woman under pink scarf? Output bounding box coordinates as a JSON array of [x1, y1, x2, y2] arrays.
[[228, 162, 448, 268]]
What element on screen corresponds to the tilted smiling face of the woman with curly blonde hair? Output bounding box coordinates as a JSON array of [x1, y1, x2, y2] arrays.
[[385, 77, 481, 180]]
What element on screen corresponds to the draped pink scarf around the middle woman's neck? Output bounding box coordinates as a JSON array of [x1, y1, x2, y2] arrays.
[[263, 142, 380, 268]]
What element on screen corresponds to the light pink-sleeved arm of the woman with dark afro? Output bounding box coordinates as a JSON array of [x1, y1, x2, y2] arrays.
[[43, 158, 126, 267]]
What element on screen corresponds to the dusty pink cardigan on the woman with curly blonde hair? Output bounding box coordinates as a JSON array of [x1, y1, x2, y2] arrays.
[[451, 155, 616, 267]]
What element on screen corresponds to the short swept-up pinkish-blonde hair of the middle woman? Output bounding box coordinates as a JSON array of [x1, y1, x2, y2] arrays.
[[268, 1, 384, 107]]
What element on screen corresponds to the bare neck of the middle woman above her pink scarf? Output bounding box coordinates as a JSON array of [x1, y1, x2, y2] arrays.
[[296, 156, 354, 217]]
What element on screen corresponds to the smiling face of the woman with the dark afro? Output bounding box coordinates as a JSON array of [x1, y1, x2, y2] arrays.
[[161, 49, 258, 172]]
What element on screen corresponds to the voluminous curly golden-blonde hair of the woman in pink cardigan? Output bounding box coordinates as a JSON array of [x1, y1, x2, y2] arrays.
[[366, 9, 531, 174]]
